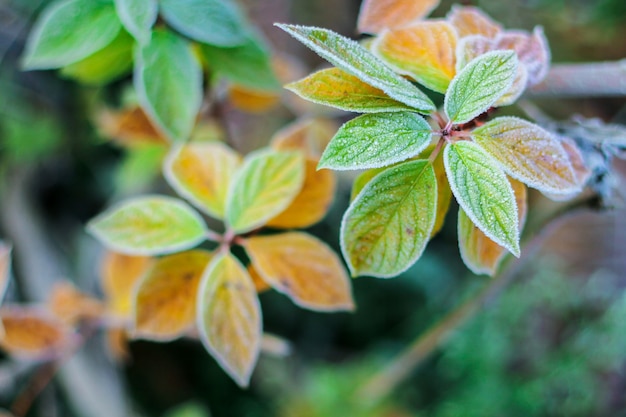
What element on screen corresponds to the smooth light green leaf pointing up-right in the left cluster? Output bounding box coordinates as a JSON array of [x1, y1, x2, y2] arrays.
[[226, 149, 305, 234]]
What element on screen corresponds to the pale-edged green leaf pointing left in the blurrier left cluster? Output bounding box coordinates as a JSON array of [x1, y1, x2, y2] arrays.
[[87, 195, 207, 255]]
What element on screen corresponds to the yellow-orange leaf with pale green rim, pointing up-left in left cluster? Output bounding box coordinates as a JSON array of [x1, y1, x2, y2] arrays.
[[163, 142, 241, 219]]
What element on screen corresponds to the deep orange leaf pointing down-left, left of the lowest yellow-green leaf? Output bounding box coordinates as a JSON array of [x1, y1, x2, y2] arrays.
[[133, 250, 213, 341]]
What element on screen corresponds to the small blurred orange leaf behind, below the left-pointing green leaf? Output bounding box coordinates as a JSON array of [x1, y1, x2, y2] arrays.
[[101, 252, 154, 320]]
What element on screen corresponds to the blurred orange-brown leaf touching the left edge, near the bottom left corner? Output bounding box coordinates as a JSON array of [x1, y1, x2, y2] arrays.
[[0, 307, 76, 360]]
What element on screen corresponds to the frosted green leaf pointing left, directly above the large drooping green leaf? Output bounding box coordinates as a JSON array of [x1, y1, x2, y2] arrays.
[[318, 112, 432, 170]]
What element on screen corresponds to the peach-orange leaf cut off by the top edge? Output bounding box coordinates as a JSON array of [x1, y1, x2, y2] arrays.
[[357, 0, 440, 34]]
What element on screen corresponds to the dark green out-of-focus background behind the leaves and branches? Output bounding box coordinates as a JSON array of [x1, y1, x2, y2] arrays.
[[0, 0, 626, 417]]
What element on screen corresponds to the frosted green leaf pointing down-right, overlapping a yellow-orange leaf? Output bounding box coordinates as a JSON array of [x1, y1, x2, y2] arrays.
[[444, 141, 520, 257]]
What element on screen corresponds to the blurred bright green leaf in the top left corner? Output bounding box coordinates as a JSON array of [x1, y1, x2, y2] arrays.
[[22, 0, 122, 70]]
